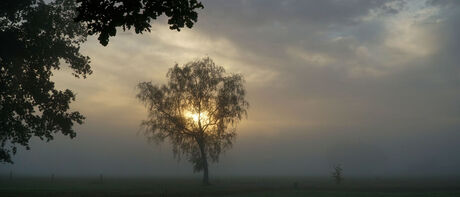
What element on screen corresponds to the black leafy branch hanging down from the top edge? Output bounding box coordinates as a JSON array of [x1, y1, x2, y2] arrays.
[[75, 0, 203, 46]]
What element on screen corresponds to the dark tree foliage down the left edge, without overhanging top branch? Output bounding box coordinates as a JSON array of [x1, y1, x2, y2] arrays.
[[0, 0, 91, 162]]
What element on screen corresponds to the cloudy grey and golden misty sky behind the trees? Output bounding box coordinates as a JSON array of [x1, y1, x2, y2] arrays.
[[0, 0, 460, 177]]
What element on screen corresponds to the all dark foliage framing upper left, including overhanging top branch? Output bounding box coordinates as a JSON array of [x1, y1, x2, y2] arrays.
[[0, 0, 203, 163]]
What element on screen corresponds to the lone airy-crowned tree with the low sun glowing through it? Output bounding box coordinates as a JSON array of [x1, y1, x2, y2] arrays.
[[137, 58, 249, 184]]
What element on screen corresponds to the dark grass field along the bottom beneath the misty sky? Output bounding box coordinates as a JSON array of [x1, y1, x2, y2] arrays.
[[0, 177, 460, 197]]
